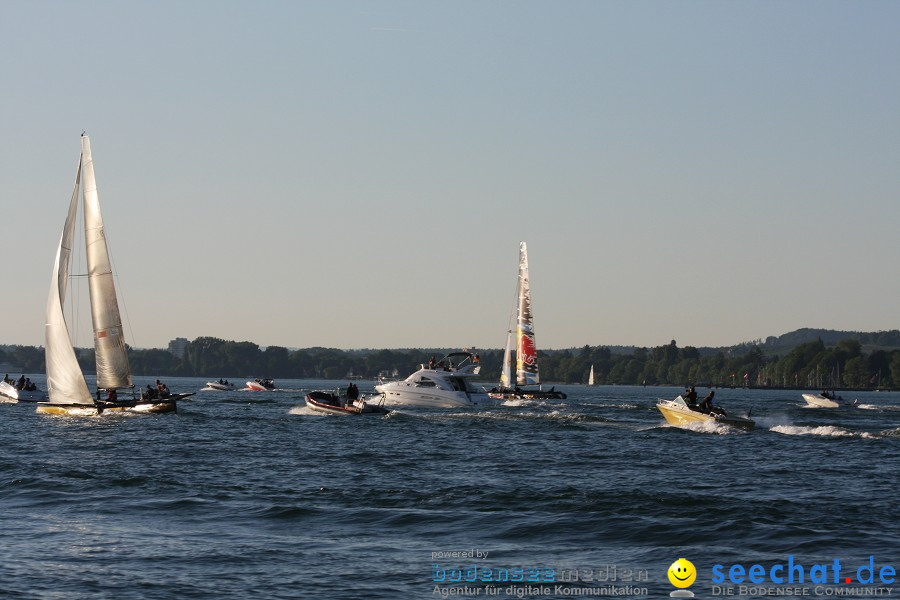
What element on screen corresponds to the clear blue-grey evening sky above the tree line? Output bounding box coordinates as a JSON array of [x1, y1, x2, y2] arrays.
[[0, 0, 900, 349]]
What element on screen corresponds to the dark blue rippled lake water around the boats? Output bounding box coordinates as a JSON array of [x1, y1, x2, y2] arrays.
[[0, 378, 900, 599]]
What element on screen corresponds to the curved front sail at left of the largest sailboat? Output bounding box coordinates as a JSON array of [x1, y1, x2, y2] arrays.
[[44, 160, 92, 404]]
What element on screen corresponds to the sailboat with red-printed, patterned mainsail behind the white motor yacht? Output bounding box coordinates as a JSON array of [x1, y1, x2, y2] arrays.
[[491, 242, 566, 399]]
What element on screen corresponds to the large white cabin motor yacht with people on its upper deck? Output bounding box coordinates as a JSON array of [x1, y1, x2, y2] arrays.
[[375, 352, 496, 408]]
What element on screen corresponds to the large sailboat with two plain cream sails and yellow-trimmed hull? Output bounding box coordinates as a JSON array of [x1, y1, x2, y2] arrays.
[[37, 134, 192, 415]]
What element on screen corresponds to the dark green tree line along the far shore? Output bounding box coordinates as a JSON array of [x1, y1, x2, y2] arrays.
[[0, 337, 900, 389]]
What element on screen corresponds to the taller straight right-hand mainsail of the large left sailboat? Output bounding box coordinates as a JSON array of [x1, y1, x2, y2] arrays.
[[81, 135, 131, 389]]
